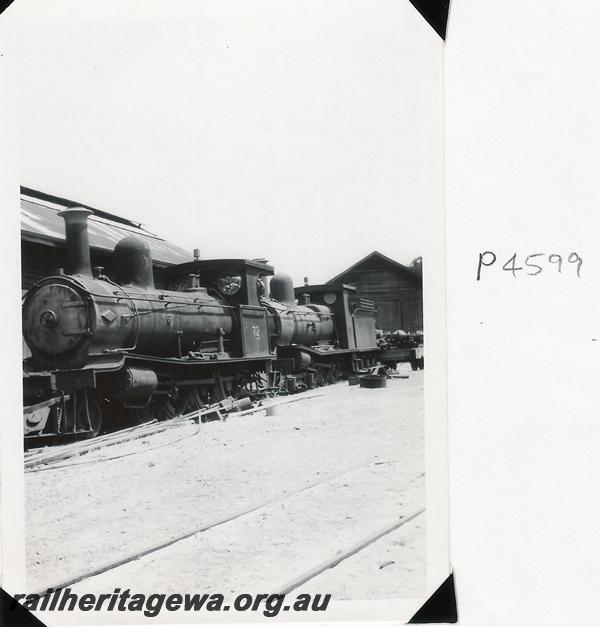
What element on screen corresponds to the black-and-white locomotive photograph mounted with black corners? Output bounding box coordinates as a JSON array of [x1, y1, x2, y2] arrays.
[[0, 0, 450, 625]]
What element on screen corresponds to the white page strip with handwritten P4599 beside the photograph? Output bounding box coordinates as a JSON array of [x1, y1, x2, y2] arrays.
[[445, 0, 600, 625]]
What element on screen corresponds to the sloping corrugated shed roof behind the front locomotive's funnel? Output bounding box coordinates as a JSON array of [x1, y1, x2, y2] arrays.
[[21, 187, 192, 265]]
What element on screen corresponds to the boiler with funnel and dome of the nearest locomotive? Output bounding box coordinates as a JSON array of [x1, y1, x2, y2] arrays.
[[23, 209, 233, 369]]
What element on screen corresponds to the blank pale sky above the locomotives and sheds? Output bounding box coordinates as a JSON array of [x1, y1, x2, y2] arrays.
[[0, 0, 442, 284]]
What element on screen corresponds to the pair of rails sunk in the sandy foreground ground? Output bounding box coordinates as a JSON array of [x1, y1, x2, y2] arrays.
[[31, 459, 425, 596]]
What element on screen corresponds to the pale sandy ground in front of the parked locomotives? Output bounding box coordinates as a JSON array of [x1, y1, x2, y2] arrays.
[[26, 372, 425, 599]]
